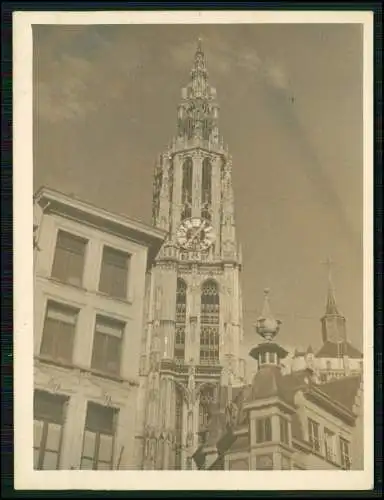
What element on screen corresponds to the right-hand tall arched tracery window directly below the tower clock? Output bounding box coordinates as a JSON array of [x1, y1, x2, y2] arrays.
[[200, 280, 220, 365]]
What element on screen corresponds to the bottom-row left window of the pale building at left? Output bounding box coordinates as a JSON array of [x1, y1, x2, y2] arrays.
[[33, 391, 67, 470]]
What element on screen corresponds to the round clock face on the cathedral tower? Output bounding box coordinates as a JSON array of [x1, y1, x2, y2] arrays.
[[176, 217, 215, 251]]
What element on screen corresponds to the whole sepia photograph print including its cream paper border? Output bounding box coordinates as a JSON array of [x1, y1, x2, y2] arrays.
[[14, 11, 373, 490]]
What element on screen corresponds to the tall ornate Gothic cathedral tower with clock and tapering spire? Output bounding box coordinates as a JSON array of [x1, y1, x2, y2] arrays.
[[137, 41, 244, 470]]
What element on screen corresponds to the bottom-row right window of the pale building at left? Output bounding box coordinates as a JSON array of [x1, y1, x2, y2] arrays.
[[81, 403, 118, 470]]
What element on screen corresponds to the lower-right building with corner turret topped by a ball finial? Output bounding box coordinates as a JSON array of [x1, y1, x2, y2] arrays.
[[194, 297, 364, 470]]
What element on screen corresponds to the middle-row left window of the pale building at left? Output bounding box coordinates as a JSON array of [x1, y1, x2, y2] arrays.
[[40, 301, 79, 363]]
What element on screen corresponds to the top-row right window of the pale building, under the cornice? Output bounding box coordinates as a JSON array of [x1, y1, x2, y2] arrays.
[[99, 247, 130, 299]]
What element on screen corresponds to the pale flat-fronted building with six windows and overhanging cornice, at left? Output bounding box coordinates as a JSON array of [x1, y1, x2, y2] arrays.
[[34, 188, 165, 469]]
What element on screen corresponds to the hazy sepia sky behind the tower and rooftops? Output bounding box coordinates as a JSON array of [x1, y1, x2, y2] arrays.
[[33, 24, 363, 356]]
